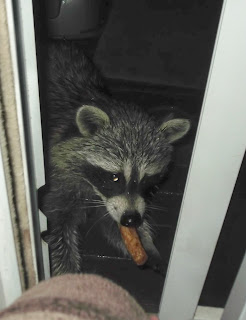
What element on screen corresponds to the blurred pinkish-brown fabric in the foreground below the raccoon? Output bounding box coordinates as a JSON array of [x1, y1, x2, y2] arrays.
[[0, 274, 149, 320]]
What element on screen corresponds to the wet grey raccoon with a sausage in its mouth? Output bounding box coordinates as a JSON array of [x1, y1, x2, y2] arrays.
[[42, 42, 190, 275]]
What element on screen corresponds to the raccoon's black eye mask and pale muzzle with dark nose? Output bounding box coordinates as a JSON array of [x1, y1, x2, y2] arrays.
[[84, 161, 161, 227]]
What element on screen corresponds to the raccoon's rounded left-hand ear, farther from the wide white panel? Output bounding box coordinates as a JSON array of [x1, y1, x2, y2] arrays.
[[76, 105, 110, 137]]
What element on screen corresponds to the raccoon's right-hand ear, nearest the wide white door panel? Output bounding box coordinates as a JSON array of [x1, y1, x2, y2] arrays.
[[160, 119, 191, 143]]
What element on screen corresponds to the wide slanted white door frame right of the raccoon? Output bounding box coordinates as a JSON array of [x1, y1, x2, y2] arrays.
[[160, 0, 246, 320]]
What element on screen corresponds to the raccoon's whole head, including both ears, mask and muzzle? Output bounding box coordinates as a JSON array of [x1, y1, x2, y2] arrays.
[[76, 106, 190, 227]]
